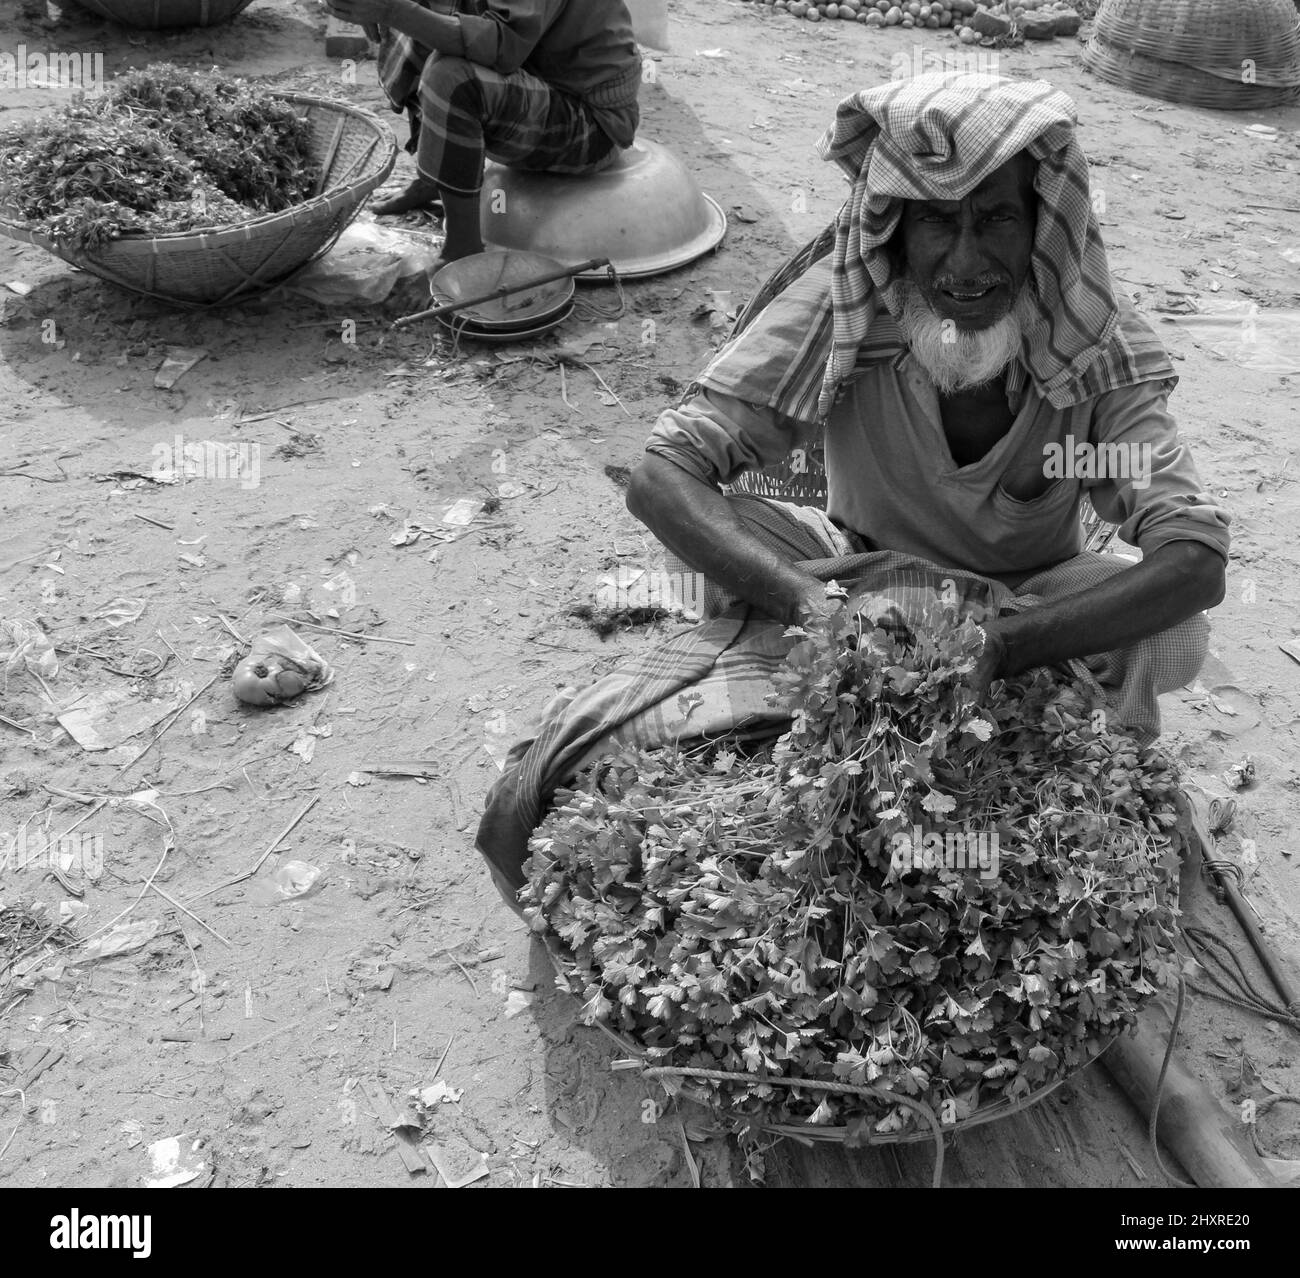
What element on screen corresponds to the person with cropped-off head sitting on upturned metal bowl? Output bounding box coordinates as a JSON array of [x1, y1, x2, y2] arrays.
[[326, 0, 641, 261]]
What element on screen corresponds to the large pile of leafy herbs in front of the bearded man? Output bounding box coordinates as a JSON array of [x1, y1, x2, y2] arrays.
[[520, 603, 1178, 1143]]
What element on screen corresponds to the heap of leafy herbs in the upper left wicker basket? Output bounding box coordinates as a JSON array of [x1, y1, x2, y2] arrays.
[[0, 64, 319, 251]]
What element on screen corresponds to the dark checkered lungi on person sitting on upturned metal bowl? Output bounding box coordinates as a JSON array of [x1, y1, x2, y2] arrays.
[[411, 53, 620, 195]]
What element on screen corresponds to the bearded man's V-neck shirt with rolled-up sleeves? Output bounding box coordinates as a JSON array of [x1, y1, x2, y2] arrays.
[[646, 352, 1230, 576]]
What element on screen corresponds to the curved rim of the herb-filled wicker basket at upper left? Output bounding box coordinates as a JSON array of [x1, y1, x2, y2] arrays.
[[0, 90, 398, 264]]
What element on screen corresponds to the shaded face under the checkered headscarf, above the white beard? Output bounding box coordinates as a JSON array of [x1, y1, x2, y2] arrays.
[[900, 152, 1037, 329]]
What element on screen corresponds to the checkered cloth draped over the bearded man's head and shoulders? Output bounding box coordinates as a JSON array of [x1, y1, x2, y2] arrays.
[[701, 72, 1174, 420]]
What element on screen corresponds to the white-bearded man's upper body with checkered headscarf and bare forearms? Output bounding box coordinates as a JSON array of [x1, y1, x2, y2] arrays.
[[628, 74, 1229, 740]]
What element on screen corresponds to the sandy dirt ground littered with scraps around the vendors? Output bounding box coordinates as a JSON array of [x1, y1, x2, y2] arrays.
[[0, 0, 1300, 1187]]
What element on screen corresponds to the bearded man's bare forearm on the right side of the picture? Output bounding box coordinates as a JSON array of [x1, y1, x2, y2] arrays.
[[974, 541, 1225, 688]]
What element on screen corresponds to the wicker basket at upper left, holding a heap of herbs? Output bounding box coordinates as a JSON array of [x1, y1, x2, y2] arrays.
[[0, 94, 398, 309]]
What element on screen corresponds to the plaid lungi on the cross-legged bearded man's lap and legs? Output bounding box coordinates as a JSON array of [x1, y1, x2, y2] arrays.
[[476, 494, 1209, 910]]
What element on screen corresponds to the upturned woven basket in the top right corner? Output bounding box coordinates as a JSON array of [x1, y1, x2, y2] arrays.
[[1093, 0, 1300, 73]]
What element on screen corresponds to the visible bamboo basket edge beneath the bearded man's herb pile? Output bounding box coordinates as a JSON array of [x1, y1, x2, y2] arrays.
[[534, 932, 1122, 1190]]
